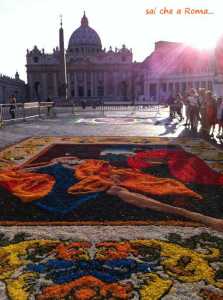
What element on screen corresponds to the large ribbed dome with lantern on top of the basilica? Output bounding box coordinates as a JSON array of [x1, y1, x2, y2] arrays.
[[68, 13, 102, 53]]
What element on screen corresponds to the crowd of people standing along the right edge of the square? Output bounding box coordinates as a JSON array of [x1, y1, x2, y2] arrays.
[[168, 89, 223, 138]]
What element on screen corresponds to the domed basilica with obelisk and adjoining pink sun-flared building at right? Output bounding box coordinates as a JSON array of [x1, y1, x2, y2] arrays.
[[26, 14, 223, 103]]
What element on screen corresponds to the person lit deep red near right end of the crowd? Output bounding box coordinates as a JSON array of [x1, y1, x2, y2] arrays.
[[206, 91, 217, 137]]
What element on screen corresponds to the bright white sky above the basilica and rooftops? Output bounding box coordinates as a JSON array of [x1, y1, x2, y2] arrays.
[[0, 0, 223, 81]]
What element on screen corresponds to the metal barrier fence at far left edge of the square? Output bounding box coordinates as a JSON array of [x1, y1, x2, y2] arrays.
[[0, 102, 54, 127]]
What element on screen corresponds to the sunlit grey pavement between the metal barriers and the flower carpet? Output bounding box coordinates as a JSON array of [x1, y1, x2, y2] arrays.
[[0, 108, 219, 148]]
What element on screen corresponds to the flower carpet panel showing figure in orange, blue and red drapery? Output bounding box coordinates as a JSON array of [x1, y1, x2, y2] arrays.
[[0, 137, 223, 224]]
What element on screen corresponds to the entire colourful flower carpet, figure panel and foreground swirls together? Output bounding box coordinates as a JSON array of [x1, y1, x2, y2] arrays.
[[0, 136, 223, 300]]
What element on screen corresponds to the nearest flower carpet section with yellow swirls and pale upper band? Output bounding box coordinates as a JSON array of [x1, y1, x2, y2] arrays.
[[0, 226, 223, 300]]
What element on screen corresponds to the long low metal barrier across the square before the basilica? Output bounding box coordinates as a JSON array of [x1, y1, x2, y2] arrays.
[[72, 102, 160, 115]]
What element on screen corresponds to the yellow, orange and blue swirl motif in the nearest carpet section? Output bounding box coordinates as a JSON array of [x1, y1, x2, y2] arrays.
[[0, 234, 223, 300]]
